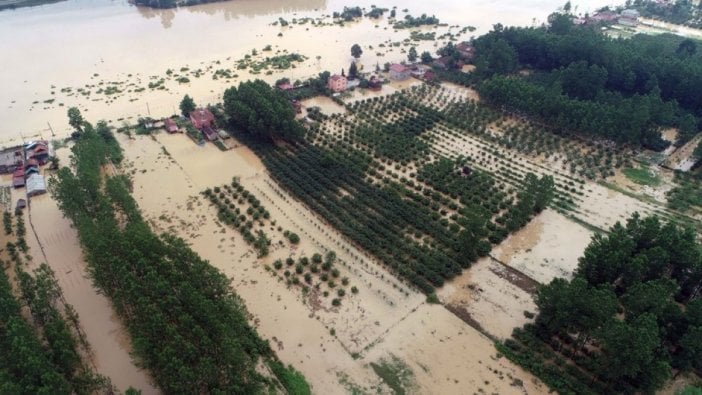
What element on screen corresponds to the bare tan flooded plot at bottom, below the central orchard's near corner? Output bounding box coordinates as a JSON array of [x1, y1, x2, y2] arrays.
[[365, 305, 548, 394]]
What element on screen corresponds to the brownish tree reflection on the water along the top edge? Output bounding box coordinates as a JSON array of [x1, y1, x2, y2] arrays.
[[135, 0, 327, 29]]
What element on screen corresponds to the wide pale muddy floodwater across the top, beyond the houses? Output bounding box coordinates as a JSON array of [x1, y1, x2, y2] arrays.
[[0, 0, 607, 144]]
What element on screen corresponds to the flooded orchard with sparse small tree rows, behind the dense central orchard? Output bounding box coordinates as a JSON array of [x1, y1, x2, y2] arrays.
[[336, 86, 699, 237]]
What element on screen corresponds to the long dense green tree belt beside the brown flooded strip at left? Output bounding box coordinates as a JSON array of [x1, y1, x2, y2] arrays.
[[50, 128, 304, 393]]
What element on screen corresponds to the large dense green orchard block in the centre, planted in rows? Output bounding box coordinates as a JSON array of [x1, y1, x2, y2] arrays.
[[262, 88, 553, 293]]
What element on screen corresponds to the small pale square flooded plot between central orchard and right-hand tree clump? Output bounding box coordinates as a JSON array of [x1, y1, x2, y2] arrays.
[[492, 209, 593, 284]]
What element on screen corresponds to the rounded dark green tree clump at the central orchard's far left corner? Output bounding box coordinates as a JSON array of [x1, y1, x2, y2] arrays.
[[224, 80, 304, 141]]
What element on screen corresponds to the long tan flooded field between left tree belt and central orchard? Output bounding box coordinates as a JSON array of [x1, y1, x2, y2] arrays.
[[121, 135, 543, 394]]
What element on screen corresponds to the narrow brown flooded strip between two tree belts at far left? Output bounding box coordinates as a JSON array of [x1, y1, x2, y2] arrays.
[[13, 159, 158, 394]]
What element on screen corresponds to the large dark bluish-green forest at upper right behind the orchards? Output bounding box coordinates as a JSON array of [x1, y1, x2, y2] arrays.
[[475, 15, 702, 150]]
